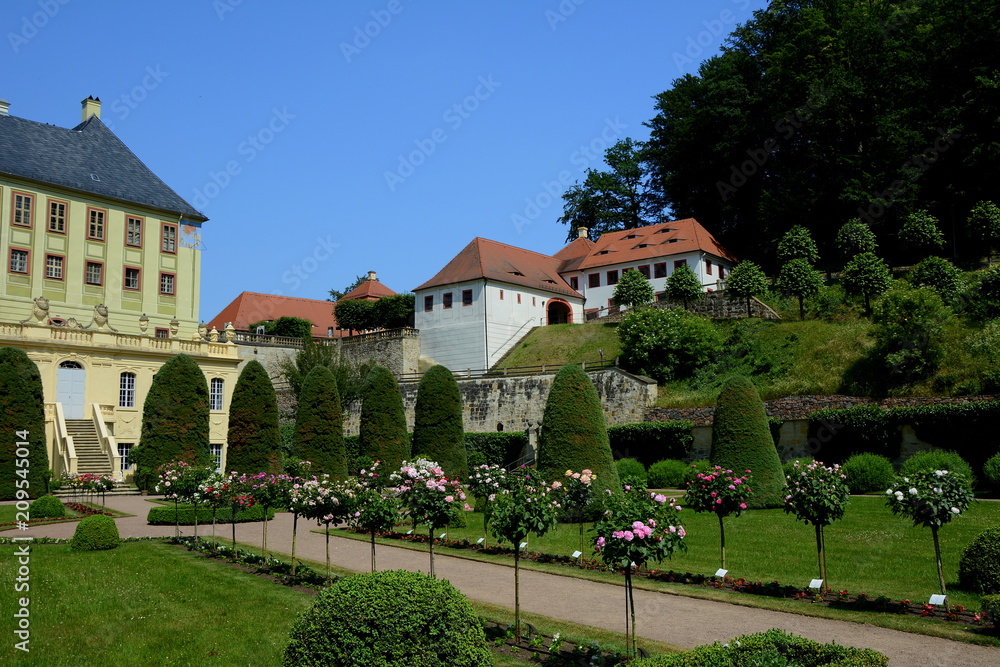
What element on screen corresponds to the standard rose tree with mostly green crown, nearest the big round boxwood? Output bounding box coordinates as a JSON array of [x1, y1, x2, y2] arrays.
[[490, 470, 559, 640]]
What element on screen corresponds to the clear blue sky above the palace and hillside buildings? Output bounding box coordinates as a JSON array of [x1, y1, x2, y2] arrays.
[[0, 0, 767, 321]]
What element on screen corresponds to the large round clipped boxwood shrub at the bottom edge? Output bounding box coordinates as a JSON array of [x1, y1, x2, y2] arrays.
[[284, 570, 493, 667]]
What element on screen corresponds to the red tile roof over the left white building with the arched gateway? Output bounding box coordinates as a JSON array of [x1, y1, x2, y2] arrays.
[[414, 237, 583, 298]]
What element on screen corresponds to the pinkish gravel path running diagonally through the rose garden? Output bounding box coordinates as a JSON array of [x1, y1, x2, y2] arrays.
[[9, 496, 1000, 667]]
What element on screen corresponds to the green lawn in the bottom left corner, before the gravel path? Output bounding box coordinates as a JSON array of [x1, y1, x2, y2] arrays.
[[0, 542, 312, 666]]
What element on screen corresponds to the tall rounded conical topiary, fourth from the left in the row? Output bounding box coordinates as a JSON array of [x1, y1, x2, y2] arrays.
[[292, 366, 347, 479]]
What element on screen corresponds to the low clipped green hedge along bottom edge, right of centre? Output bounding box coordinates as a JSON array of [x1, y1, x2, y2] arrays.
[[629, 629, 889, 667]]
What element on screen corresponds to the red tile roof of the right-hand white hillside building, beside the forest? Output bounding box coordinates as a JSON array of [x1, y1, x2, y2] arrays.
[[568, 218, 737, 272]]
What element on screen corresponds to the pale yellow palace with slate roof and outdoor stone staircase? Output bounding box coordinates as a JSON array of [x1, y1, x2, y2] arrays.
[[0, 97, 239, 479]]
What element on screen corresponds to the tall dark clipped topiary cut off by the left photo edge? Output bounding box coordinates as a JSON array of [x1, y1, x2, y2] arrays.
[[0, 347, 49, 500]]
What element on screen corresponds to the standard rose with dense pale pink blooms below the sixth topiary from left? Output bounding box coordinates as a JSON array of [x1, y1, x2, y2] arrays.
[[389, 459, 472, 577]]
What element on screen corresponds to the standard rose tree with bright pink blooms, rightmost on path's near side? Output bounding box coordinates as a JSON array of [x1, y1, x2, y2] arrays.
[[593, 489, 687, 656]]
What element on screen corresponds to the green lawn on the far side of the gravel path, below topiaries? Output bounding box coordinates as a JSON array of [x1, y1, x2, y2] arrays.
[[350, 496, 1000, 609]]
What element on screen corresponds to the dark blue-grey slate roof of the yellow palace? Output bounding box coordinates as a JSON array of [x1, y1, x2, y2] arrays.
[[0, 116, 208, 222]]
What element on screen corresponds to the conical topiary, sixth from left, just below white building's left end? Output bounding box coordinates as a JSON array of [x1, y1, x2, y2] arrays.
[[413, 364, 469, 480]]
